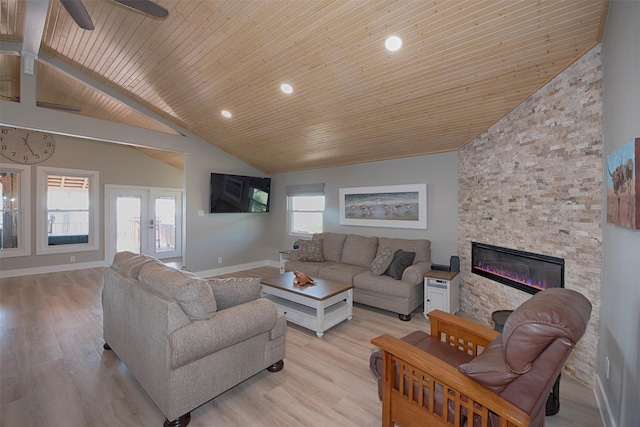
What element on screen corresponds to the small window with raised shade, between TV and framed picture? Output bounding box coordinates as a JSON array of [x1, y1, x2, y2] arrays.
[[287, 184, 325, 237]]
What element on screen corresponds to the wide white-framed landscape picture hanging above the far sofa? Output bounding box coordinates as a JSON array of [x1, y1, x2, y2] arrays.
[[340, 184, 427, 228]]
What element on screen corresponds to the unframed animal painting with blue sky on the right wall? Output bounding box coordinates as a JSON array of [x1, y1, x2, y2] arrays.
[[607, 138, 640, 230]]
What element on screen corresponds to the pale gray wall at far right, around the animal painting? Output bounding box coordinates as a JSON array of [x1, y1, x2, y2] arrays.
[[596, 0, 640, 427]]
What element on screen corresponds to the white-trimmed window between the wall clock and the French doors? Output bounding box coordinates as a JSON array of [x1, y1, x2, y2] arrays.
[[36, 167, 99, 255]]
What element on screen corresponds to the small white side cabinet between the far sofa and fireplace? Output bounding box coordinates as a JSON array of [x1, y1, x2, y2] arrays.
[[424, 270, 460, 316]]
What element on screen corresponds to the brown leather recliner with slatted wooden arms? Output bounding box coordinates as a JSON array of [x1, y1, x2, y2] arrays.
[[370, 289, 591, 426]]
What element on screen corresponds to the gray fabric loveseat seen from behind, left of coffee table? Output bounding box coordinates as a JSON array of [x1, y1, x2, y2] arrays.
[[102, 252, 287, 427]]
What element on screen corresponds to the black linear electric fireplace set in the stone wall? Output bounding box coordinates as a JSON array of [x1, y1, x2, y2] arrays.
[[471, 242, 564, 294]]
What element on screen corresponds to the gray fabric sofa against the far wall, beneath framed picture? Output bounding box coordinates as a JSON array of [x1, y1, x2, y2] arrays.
[[285, 233, 431, 320]]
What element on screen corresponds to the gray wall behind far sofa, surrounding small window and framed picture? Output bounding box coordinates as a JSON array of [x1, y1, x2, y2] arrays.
[[268, 152, 458, 265]]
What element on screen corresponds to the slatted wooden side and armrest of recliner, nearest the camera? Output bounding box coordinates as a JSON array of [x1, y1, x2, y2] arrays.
[[371, 334, 529, 427]]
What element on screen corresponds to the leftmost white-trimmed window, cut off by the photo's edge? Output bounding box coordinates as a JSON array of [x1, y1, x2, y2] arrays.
[[0, 165, 31, 258]]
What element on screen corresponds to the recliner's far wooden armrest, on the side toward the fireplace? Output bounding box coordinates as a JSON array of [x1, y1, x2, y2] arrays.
[[427, 310, 500, 356]]
